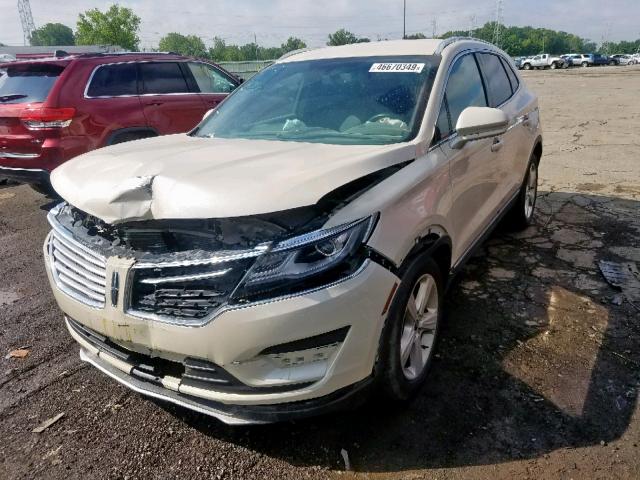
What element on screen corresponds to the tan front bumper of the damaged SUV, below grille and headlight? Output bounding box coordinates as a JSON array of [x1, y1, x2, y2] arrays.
[[45, 238, 398, 423]]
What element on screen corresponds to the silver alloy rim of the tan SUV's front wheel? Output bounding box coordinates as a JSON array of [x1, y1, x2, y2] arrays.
[[400, 273, 440, 380]]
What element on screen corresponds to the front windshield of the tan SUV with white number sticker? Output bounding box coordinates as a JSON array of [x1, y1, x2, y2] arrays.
[[193, 56, 439, 145]]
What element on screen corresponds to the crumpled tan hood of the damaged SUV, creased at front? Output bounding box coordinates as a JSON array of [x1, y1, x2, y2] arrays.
[[51, 135, 416, 223]]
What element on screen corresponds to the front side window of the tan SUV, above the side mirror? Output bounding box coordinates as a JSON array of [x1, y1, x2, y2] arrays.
[[445, 54, 487, 129]]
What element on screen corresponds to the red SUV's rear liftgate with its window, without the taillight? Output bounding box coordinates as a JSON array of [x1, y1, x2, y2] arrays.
[[0, 63, 66, 161]]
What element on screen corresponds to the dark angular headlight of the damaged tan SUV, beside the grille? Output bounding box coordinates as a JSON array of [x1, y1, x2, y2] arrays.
[[234, 216, 375, 300]]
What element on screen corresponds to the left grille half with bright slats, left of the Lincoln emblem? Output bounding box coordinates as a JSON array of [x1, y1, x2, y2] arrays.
[[48, 230, 107, 308]]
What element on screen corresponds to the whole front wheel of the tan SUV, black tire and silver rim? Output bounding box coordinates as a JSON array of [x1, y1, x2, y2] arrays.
[[375, 253, 445, 402]]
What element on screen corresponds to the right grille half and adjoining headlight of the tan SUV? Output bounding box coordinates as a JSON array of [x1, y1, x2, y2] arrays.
[[127, 216, 377, 325]]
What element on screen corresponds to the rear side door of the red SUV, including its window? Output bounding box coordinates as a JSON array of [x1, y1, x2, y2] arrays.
[[138, 62, 207, 135]]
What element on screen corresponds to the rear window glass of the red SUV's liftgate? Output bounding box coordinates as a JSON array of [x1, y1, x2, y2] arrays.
[[0, 65, 64, 105]]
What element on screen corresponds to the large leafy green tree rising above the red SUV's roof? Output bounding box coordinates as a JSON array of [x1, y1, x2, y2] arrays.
[[76, 4, 140, 50]]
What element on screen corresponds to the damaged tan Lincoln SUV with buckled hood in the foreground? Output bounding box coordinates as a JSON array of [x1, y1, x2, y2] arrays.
[[44, 38, 542, 424]]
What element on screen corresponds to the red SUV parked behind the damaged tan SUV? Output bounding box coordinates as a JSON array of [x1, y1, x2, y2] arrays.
[[0, 53, 241, 191]]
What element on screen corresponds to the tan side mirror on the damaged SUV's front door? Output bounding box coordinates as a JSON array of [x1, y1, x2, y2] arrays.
[[451, 107, 509, 150]]
